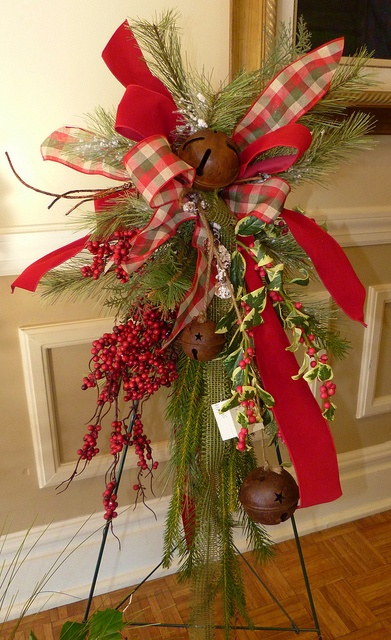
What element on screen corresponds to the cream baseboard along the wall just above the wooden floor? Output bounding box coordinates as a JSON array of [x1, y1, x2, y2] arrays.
[[0, 441, 391, 618]]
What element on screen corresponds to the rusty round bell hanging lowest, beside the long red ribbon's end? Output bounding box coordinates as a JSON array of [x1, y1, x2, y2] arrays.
[[239, 465, 299, 524]]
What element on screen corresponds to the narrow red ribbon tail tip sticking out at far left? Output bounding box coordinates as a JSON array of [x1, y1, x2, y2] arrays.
[[11, 235, 90, 293]]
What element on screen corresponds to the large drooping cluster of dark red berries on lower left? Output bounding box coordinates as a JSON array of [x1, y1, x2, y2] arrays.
[[62, 306, 177, 520]]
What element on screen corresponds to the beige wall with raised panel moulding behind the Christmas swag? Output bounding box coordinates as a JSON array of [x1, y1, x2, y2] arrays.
[[0, 0, 391, 531]]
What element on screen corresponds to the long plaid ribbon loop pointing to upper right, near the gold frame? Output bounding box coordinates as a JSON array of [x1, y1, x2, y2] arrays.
[[232, 38, 344, 149]]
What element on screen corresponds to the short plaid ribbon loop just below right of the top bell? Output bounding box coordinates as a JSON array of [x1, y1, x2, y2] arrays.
[[223, 178, 290, 223]]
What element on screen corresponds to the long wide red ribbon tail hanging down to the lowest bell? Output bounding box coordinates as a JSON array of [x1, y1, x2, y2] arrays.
[[246, 256, 342, 507]]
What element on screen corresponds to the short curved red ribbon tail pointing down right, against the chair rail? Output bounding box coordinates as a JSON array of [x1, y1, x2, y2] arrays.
[[281, 209, 366, 325]]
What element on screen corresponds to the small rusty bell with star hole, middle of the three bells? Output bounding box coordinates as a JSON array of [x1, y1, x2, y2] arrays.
[[179, 319, 225, 362]]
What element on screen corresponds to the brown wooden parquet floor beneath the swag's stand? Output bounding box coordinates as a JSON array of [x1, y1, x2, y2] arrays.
[[0, 511, 391, 640]]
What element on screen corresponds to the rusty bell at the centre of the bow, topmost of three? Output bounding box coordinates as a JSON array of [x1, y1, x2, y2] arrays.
[[177, 129, 240, 191]]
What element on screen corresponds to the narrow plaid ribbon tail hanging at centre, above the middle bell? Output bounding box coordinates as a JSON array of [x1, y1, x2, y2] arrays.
[[163, 218, 215, 347]]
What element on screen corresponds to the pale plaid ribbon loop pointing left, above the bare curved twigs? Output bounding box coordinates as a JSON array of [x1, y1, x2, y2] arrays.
[[41, 127, 129, 182]]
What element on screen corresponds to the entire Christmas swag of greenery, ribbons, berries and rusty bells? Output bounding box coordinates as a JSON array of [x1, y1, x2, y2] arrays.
[[13, 11, 371, 633]]
